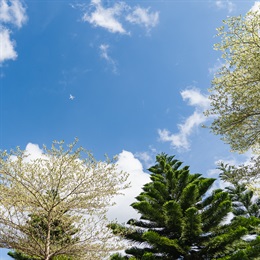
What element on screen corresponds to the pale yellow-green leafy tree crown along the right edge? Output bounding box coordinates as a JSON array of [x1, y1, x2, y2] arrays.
[[205, 8, 260, 153]]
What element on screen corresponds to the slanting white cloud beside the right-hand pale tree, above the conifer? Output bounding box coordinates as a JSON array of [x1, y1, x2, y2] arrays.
[[158, 88, 210, 150]]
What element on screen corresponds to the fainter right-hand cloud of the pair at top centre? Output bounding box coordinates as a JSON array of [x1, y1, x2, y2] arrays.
[[126, 6, 159, 30]]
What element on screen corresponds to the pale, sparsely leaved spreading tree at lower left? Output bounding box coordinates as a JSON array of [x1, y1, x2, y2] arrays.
[[0, 141, 127, 260]]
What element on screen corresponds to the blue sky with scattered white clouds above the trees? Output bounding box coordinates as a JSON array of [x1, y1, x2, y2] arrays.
[[0, 0, 259, 259]]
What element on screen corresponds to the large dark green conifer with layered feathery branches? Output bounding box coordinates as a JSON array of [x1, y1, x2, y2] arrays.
[[111, 154, 260, 260]]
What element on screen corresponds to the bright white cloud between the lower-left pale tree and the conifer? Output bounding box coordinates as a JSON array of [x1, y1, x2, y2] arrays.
[[108, 151, 150, 223]]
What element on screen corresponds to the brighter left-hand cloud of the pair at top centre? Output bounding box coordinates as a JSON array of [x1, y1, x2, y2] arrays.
[[83, 0, 126, 33]]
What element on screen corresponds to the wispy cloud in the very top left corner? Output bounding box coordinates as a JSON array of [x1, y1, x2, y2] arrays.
[[0, 0, 27, 28]]
